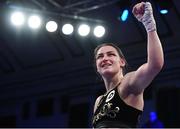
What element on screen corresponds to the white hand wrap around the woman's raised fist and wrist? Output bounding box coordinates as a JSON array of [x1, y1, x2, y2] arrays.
[[135, 2, 156, 32]]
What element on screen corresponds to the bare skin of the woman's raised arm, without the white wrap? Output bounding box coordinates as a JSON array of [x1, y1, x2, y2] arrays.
[[129, 3, 164, 93]]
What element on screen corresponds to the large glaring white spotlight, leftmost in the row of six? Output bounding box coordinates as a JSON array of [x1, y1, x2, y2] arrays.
[[11, 12, 25, 26]]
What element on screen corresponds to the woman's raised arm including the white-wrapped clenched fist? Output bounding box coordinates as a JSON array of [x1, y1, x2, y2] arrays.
[[129, 2, 164, 93]]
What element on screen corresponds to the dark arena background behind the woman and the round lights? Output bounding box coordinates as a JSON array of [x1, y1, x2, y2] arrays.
[[0, 0, 180, 127]]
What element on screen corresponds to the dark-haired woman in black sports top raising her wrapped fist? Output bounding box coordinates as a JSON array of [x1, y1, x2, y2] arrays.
[[93, 2, 164, 128]]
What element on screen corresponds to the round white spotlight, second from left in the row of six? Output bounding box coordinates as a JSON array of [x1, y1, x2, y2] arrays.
[[28, 15, 41, 29]]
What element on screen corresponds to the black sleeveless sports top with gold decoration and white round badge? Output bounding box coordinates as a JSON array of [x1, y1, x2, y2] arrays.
[[93, 87, 142, 128]]
